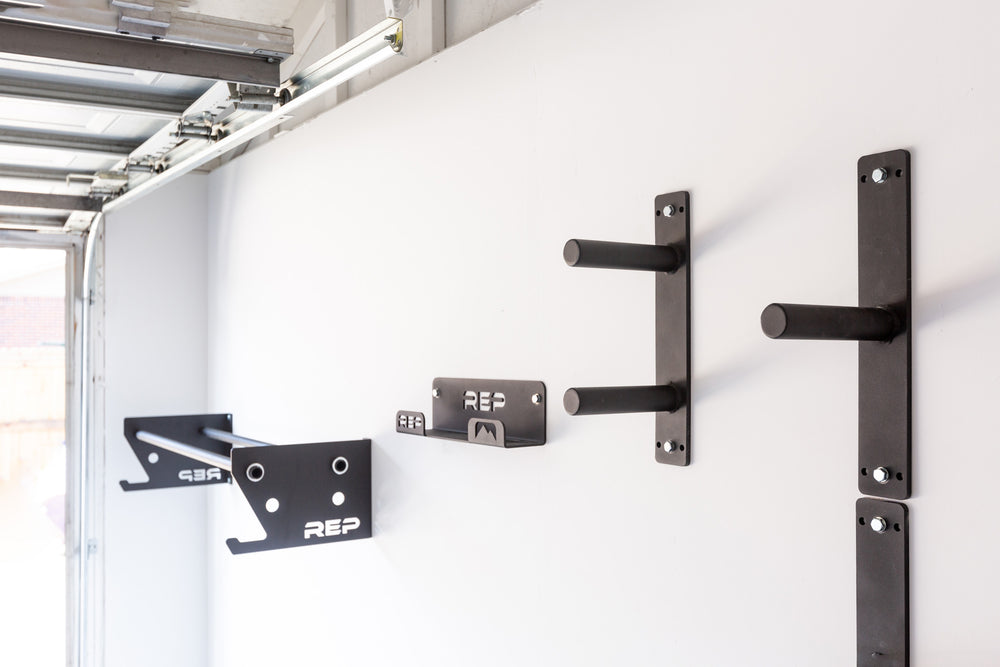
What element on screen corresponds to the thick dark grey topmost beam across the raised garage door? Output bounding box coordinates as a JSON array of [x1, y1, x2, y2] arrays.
[[0, 18, 281, 86]]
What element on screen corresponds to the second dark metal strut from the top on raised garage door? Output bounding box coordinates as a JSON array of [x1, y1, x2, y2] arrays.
[[0, 74, 191, 119]]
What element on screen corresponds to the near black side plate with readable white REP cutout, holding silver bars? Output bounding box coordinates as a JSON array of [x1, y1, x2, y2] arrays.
[[226, 440, 372, 554]]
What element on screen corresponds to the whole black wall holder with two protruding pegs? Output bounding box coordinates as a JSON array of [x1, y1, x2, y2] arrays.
[[563, 191, 691, 466]]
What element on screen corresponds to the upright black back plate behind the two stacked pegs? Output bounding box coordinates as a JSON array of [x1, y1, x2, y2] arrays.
[[654, 191, 691, 466]]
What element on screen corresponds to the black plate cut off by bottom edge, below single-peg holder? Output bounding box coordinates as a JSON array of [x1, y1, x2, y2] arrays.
[[855, 498, 910, 667]]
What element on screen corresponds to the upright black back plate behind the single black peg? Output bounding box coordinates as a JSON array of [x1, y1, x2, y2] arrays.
[[858, 150, 912, 499]]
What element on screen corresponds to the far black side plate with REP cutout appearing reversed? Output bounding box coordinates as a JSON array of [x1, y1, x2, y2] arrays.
[[121, 414, 233, 491]]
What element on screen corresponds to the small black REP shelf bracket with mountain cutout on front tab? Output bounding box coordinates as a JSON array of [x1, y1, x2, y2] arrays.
[[396, 378, 545, 448]]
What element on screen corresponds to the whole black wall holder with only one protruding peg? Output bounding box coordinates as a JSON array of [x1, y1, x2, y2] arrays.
[[760, 150, 912, 499]]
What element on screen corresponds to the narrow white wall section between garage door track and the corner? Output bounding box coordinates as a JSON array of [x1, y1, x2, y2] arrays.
[[102, 176, 212, 667]]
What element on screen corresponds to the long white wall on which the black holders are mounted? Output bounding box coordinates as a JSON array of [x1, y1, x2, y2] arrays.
[[197, 0, 1000, 667]]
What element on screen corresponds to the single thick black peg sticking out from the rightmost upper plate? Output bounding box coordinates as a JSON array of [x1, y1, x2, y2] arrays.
[[760, 303, 899, 341]]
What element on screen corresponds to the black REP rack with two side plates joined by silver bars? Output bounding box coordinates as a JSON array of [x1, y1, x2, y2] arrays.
[[121, 414, 372, 554]]
